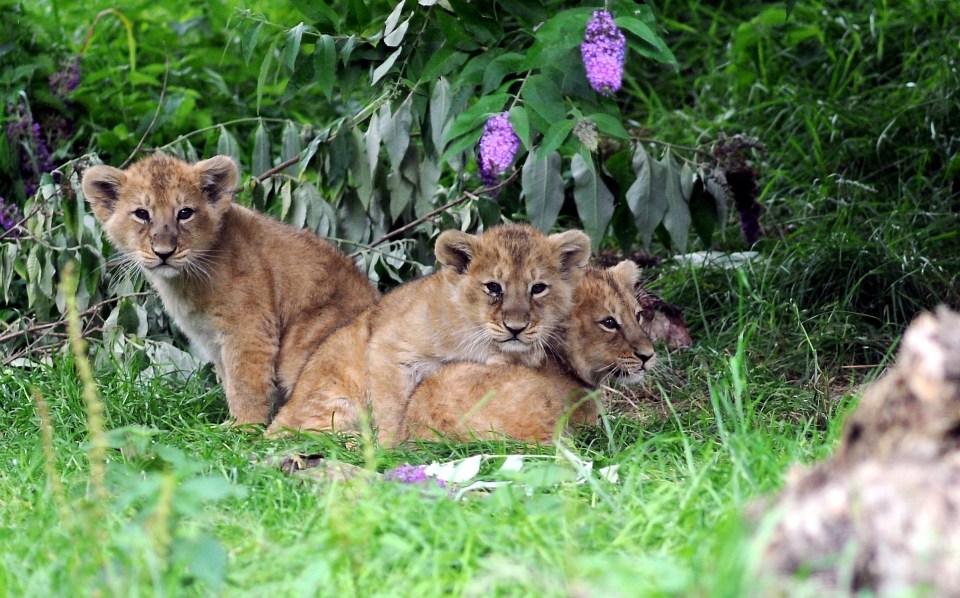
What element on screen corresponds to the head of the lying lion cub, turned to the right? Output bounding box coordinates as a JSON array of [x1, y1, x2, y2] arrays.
[[564, 261, 656, 387]]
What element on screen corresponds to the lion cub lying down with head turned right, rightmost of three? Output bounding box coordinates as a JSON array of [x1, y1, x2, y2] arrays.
[[402, 261, 655, 442]]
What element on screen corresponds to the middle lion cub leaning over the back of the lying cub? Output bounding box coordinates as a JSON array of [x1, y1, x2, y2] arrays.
[[269, 224, 590, 443]]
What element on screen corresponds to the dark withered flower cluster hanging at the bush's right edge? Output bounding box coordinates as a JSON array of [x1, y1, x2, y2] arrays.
[[710, 135, 766, 245]]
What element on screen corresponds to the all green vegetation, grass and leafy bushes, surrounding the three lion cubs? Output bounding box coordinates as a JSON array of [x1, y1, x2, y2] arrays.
[[0, 0, 960, 595]]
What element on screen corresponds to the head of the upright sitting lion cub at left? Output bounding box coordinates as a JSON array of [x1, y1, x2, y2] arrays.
[[83, 154, 238, 279]]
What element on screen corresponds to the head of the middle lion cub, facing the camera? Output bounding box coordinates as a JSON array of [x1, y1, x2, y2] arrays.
[[435, 224, 590, 366]]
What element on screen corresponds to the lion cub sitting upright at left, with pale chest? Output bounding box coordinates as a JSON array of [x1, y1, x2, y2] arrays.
[[83, 154, 377, 424]]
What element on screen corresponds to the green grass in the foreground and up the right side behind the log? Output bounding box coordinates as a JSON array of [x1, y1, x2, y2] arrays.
[[0, 2, 960, 596]]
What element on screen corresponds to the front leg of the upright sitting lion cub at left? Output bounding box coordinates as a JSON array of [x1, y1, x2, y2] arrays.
[[220, 326, 279, 425]]
